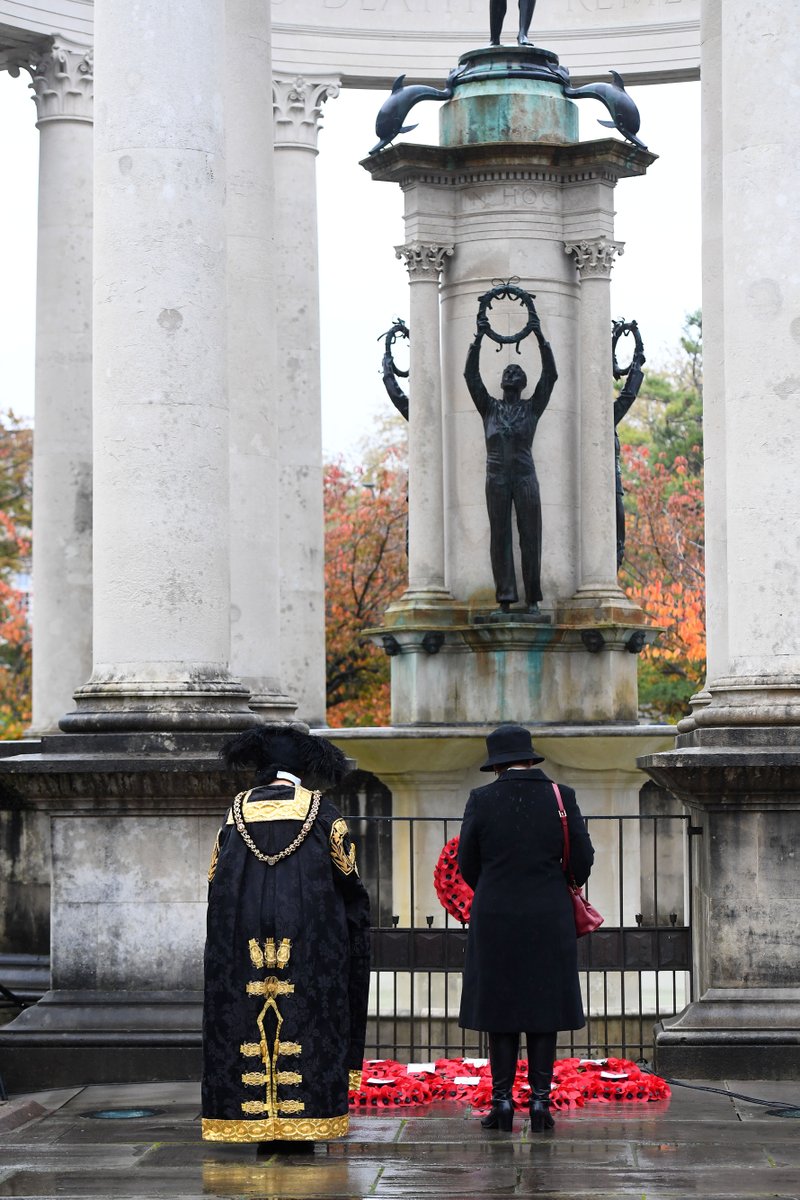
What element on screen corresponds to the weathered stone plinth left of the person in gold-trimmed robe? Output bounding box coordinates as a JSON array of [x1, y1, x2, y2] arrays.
[[0, 734, 235, 1091]]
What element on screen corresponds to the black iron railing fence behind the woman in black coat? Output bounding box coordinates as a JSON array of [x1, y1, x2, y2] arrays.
[[340, 790, 693, 1062]]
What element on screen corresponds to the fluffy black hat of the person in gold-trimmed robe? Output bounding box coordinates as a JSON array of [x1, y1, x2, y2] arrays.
[[219, 725, 350, 788]]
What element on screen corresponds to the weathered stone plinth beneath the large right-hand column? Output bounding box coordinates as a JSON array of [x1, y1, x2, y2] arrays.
[[639, 724, 800, 1079]]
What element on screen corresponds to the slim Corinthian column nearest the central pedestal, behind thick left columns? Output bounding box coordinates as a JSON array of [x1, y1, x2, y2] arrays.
[[273, 77, 339, 725]]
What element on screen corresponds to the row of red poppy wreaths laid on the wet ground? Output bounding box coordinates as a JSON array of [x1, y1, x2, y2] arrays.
[[350, 1058, 670, 1109]]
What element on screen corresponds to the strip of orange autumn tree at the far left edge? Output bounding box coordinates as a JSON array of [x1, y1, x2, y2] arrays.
[[0, 413, 32, 738]]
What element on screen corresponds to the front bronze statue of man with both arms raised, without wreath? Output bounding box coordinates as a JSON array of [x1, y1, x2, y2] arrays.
[[464, 311, 558, 619]]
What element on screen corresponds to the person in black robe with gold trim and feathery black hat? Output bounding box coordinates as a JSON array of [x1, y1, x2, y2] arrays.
[[203, 726, 369, 1152]]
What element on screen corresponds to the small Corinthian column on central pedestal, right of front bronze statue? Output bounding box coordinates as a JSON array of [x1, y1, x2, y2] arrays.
[[565, 238, 628, 624]]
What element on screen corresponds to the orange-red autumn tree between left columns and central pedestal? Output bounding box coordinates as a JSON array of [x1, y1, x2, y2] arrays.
[[324, 420, 408, 727]]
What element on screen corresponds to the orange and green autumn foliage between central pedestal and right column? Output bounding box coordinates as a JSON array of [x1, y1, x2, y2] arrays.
[[619, 313, 705, 720]]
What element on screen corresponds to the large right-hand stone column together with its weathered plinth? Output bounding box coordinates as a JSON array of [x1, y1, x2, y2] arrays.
[[642, 0, 800, 1079]]
